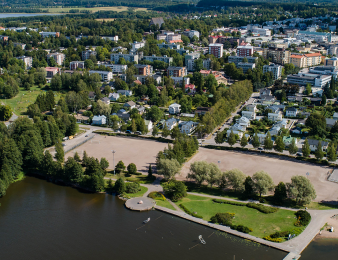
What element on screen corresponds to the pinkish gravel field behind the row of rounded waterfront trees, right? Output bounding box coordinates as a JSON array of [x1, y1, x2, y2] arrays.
[[181, 147, 338, 202]]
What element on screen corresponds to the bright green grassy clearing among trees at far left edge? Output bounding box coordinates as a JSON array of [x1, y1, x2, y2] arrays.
[[1, 86, 61, 116]]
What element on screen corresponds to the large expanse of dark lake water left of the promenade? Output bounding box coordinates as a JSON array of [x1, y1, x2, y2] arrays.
[[0, 177, 286, 260]]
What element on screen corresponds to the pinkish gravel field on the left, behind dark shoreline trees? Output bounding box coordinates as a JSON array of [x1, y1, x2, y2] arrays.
[[73, 135, 168, 174]]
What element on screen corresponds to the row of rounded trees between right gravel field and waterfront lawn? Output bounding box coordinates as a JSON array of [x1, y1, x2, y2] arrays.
[[188, 161, 316, 205]]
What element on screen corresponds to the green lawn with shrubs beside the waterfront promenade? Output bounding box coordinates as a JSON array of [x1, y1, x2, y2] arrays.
[[176, 195, 298, 238]]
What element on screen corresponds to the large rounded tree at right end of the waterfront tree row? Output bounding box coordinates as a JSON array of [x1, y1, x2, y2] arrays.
[[287, 175, 317, 205]]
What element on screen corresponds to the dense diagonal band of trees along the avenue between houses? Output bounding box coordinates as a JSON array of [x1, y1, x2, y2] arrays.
[[198, 80, 252, 134]]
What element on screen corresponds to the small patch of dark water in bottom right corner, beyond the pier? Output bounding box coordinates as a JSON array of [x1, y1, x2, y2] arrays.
[[301, 238, 338, 260]]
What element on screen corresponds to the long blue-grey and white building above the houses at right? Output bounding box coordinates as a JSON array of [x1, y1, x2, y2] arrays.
[[287, 73, 331, 88]]
